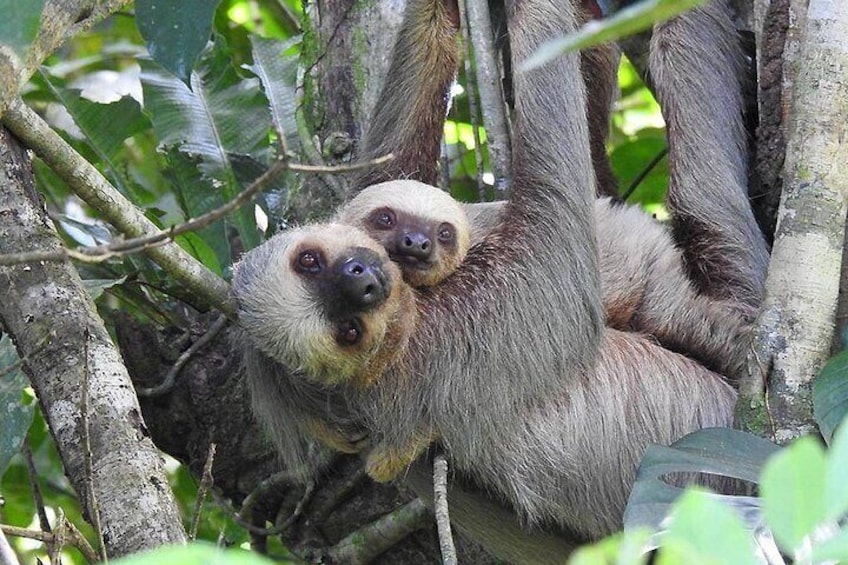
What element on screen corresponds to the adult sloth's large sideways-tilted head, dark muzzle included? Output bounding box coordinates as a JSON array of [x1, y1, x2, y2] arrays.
[[233, 224, 408, 384]]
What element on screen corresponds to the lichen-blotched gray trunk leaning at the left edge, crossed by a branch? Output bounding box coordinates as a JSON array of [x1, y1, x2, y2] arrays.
[[0, 129, 185, 556]]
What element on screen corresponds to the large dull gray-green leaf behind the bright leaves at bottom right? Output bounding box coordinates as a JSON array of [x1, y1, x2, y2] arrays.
[[624, 428, 780, 530]]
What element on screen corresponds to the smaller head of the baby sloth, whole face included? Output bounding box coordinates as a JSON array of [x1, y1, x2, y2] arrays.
[[336, 180, 470, 287]]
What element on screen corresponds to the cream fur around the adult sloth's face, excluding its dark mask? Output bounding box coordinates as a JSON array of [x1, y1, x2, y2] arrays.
[[233, 224, 401, 384]]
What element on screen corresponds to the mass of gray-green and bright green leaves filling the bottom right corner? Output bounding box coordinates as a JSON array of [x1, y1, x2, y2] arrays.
[[584, 408, 848, 565]]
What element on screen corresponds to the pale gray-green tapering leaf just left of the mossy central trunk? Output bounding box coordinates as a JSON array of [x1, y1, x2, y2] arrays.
[[250, 35, 300, 153]]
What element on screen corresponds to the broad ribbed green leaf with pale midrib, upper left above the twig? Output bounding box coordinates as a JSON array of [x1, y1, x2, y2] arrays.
[[141, 39, 271, 258]]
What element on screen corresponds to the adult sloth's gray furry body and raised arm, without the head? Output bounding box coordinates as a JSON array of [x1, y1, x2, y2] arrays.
[[362, 0, 735, 539]]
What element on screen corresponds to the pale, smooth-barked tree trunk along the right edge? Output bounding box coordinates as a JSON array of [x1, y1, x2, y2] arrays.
[[743, 0, 848, 443]]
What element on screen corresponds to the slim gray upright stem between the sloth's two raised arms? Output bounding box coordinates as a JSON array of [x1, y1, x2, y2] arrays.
[[460, 0, 512, 200]]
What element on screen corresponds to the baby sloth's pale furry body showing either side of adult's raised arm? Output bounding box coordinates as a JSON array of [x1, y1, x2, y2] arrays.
[[464, 198, 750, 382]]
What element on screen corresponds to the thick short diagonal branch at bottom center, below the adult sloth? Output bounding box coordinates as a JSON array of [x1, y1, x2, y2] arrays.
[[326, 498, 430, 565]]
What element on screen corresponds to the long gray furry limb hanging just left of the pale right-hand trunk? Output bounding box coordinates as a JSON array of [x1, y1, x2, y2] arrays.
[[649, 0, 768, 310]]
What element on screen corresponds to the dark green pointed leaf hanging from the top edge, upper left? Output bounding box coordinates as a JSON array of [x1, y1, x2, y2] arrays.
[[135, 0, 219, 84]]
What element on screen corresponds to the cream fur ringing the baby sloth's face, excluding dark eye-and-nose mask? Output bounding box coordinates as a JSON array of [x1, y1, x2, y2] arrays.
[[335, 180, 471, 287]]
